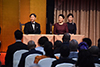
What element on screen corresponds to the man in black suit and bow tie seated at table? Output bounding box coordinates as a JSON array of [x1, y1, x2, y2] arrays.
[[24, 13, 41, 34]]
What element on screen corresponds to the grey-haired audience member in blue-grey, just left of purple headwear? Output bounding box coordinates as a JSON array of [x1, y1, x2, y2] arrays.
[[68, 39, 78, 58]]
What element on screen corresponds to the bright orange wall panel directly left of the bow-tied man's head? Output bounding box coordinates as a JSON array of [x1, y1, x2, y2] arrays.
[[19, 0, 30, 24]]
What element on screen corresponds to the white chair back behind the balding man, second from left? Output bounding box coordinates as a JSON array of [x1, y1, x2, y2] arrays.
[[25, 54, 41, 67]]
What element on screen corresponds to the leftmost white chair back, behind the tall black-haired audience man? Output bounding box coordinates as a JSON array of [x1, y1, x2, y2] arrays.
[[13, 50, 28, 67]]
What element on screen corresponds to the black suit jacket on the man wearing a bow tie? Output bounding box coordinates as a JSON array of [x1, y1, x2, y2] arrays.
[[24, 22, 41, 34]]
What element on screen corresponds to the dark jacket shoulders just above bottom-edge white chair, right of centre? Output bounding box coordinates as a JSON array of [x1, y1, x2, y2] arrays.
[[51, 58, 76, 67]]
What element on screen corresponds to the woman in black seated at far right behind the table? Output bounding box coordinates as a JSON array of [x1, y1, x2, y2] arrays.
[[67, 13, 76, 34]]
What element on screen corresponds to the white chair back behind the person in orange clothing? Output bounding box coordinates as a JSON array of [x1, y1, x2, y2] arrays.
[[38, 58, 56, 67]]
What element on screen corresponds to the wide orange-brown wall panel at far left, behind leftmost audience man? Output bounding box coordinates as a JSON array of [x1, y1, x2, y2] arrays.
[[1, 0, 19, 52]]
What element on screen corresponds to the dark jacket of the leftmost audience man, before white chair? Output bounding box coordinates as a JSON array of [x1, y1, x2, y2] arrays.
[[5, 42, 28, 67]]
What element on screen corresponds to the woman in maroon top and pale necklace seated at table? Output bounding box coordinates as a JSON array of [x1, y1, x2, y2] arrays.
[[54, 14, 68, 34]]
